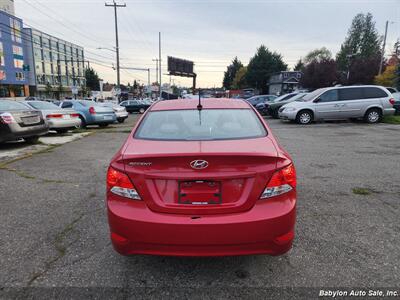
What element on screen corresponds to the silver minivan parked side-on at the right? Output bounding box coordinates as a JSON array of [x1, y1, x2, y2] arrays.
[[279, 85, 395, 124]]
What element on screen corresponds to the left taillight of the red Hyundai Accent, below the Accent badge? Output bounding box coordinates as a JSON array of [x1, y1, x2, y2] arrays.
[[107, 167, 141, 200]]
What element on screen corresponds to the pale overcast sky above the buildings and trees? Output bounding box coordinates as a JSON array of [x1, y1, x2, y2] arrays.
[[15, 0, 400, 87]]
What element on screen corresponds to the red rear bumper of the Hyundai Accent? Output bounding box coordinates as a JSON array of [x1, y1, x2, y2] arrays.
[[108, 191, 296, 256]]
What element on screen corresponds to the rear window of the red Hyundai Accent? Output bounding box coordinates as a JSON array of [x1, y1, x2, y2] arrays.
[[135, 109, 267, 141]]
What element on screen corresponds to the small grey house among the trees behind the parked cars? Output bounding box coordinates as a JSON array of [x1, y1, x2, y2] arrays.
[[268, 71, 303, 95]]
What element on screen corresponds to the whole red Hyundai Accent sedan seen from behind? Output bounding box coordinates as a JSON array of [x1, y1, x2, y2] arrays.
[[107, 99, 296, 256]]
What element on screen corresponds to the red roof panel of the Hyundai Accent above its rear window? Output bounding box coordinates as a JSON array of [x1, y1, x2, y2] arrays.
[[151, 98, 250, 111]]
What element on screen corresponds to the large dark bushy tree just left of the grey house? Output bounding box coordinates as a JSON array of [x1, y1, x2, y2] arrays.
[[246, 45, 287, 93]]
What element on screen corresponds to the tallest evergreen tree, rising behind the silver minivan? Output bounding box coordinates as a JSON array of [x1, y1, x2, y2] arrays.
[[336, 13, 381, 73]]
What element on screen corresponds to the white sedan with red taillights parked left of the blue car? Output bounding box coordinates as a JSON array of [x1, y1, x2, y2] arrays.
[[24, 101, 81, 133]]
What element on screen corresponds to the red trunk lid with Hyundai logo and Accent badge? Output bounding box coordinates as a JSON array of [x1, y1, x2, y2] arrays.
[[123, 137, 277, 214]]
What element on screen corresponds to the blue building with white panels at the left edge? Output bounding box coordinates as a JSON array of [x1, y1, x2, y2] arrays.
[[0, 9, 29, 97]]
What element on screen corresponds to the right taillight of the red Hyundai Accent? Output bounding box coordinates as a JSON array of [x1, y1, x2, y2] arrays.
[[260, 164, 296, 199]]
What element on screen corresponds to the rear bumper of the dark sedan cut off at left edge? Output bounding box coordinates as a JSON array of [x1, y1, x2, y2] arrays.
[[0, 123, 49, 142]]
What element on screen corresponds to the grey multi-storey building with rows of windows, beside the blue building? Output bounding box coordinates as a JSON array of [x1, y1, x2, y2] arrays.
[[22, 28, 86, 98]]
